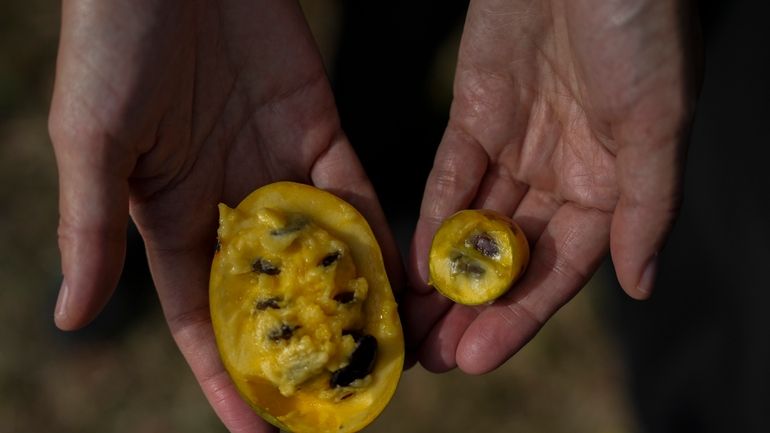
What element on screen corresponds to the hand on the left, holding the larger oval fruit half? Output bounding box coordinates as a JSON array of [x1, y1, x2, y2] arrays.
[[50, 0, 401, 432]]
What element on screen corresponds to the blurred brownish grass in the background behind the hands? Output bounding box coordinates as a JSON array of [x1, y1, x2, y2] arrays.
[[0, 0, 635, 433]]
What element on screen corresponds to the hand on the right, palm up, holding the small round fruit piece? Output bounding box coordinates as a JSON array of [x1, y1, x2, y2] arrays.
[[404, 0, 696, 373]]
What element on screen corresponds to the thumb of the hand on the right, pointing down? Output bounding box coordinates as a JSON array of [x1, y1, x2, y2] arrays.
[[610, 138, 683, 299]]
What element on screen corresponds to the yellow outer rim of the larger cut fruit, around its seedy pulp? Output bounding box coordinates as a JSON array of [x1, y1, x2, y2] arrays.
[[209, 182, 404, 433]]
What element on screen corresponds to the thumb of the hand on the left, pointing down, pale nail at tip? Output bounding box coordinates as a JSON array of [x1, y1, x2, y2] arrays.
[[49, 110, 135, 330]]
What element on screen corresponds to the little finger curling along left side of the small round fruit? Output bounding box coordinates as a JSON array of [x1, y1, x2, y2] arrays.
[[409, 122, 488, 293]]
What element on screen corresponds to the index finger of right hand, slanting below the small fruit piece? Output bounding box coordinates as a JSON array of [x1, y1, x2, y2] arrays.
[[457, 204, 610, 374]]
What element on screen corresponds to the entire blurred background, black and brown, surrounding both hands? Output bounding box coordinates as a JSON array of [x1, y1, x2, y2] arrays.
[[0, 0, 770, 433]]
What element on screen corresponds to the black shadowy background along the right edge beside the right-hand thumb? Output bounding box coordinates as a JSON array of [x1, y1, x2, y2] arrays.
[[603, 0, 770, 432]]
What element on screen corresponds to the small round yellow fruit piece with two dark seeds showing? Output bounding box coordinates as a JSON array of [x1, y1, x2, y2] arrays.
[[429, 209, 529, 305]]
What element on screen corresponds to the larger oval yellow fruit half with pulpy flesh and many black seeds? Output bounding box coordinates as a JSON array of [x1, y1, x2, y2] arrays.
[[209, 182, 404, 433]]
